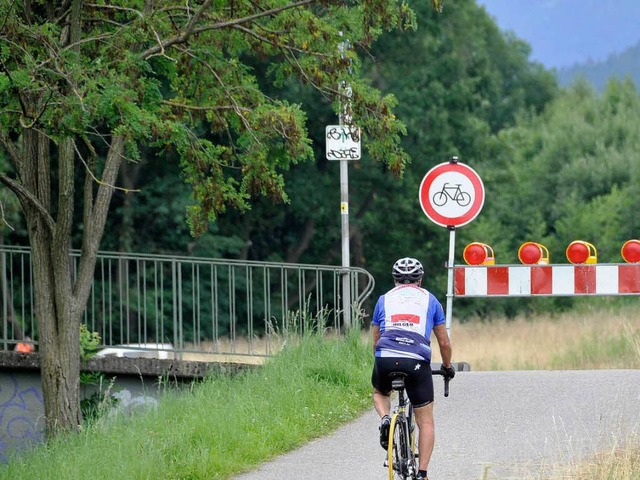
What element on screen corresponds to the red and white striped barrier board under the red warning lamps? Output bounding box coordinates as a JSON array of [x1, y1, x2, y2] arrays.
[[454, 264, 640, 297]]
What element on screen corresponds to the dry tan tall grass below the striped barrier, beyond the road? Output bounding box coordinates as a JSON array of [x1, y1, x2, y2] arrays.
[[434, 308, 640, 370]]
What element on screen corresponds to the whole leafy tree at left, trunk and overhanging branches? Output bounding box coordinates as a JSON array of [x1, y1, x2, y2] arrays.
[[0, 0, 432, 436]]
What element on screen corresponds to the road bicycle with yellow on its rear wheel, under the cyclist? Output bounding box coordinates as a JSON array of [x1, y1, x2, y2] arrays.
[[385, 370, 451, 480]]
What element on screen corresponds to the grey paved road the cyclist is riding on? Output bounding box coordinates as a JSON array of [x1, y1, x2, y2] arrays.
[[236, 370, 640, 480]]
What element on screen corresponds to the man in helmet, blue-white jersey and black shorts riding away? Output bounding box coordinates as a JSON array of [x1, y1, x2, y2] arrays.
[[371, 257, 455, 480]]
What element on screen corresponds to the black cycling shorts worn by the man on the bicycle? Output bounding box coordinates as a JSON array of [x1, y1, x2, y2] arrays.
[[371, 357, 433, 408]]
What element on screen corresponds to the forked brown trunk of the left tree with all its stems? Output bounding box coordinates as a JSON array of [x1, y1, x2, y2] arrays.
[[16, 125, 124, 438]]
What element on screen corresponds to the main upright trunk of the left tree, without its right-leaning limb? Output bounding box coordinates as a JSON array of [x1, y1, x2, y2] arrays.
[[19, 129, 81, 436]]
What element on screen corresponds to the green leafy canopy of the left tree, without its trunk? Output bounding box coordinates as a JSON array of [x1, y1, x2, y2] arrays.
[[0, 0, 414, 240]]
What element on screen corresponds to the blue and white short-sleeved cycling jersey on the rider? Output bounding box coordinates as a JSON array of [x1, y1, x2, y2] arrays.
[[371, 284, 445, 362]]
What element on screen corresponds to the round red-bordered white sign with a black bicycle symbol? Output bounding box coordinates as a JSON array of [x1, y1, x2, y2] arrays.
[[419, 162, 484, 227]]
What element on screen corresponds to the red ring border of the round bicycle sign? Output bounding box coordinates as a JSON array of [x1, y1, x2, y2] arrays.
[[418, 162, 484, 227]]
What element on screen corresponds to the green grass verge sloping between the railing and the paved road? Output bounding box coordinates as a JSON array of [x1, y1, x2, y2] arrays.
[[0, 333, 372, 480]]
